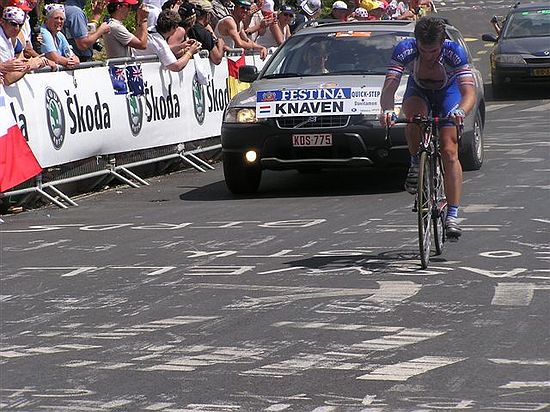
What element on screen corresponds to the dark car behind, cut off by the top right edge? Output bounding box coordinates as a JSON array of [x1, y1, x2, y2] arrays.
[[482, 3, 550, 96]]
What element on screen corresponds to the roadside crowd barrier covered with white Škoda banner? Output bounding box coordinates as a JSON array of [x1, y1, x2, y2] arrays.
[[0, 49, 272, 208]]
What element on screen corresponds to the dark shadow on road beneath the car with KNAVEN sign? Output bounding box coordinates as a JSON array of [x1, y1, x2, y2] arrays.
[[180, 168, 406, 201]]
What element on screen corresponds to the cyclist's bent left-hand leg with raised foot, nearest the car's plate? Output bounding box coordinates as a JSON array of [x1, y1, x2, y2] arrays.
[[403, 81, 429, 194]]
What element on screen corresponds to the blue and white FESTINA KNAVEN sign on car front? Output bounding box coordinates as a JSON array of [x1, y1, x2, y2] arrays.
[[256, 87, 380, 118]]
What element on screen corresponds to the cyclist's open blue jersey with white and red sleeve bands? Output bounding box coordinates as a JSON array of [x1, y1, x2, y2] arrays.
[[386, 38, 475, 90]]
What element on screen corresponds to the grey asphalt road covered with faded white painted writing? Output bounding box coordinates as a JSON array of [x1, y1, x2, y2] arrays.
[[0, 1, 550, 412]]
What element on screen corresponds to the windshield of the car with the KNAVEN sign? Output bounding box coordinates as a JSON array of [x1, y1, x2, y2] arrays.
[[262, 31, 407, 78]]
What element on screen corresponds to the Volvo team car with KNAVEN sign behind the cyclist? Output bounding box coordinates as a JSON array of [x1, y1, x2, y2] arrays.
[[221, 21, 485, 194]]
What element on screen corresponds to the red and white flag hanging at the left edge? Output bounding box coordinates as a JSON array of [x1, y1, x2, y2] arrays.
[[0, 86, 42, 192]]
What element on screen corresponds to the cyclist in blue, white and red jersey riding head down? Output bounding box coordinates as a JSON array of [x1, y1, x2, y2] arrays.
[[380, 17, 476, 239]]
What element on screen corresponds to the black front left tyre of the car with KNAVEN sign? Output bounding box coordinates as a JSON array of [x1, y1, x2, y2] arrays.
[[223, 153, 262, 195]]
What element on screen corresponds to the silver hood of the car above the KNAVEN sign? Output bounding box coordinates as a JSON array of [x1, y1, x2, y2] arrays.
[[229, 75, 407, 107]]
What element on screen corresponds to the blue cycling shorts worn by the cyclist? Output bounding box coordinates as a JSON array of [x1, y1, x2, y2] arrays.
[[403, 76, 462, 127]]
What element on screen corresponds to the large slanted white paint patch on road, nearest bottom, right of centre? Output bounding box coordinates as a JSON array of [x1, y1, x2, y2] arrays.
[[356, 356, 467, 382]]
